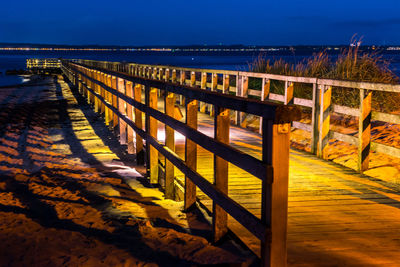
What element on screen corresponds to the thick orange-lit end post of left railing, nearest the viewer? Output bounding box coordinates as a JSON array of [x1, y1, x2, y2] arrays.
[[261, 119, 290, 267]]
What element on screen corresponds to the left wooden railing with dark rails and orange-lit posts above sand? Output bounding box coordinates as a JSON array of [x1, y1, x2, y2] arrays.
[[61, 60, 300, 266]]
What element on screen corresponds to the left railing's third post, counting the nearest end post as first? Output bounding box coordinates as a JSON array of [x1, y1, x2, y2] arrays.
[[184, 99, 198, 210]]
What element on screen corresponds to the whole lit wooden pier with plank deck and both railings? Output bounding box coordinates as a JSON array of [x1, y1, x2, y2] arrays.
[[45, 60, 400, 266]]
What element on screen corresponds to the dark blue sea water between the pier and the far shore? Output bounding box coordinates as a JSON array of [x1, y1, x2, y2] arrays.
[[0, 51, 400, 86]]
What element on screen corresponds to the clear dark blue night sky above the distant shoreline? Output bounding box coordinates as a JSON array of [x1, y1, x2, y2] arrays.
[[0, 0, 400, 45]]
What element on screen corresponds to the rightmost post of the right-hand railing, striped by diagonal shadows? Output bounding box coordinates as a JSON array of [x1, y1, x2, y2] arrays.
[[357, 89, 372, 173]]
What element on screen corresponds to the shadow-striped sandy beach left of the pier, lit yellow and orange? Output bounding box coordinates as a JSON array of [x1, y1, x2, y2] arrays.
[[0, 76, 249, 266]]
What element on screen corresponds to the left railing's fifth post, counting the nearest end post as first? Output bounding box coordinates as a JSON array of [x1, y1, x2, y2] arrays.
[[145, 85, 158, 184]]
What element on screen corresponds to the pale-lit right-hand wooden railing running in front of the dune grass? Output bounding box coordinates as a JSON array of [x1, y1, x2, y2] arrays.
[[74, 60, 400, 172]]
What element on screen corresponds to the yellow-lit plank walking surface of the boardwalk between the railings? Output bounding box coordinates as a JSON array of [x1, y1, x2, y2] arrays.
[[165, 110, 400, 266]]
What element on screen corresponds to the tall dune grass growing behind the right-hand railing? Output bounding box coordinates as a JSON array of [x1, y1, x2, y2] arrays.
[[249, 41, 400, 112]]
